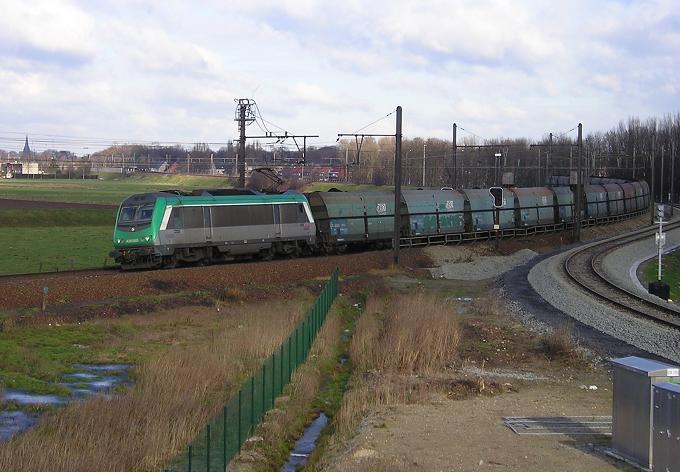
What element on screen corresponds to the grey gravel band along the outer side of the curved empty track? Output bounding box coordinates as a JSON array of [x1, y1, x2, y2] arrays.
[[528, 245, 679, 362]]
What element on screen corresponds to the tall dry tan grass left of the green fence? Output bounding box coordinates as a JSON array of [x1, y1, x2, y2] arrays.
[[0, 303, 303, 471]]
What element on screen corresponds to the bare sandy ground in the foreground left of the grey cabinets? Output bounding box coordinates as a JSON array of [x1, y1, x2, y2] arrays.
[[329, 378, 633, 471]]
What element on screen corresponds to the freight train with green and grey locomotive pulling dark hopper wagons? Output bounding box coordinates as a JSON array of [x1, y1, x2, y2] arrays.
[[110, 178, 650, 270]]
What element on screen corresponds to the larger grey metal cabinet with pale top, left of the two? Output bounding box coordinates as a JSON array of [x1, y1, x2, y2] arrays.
[[611, 356, 679, 469]]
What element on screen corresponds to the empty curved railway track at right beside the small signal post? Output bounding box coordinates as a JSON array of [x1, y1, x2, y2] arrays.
[[564, 222, 679, 328]]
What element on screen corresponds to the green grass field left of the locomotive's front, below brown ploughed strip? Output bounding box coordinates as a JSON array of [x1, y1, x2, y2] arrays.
[[0, 223, 113, 275]]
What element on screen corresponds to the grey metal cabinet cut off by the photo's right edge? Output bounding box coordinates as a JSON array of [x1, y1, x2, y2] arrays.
[[653, 383, 679, 471]]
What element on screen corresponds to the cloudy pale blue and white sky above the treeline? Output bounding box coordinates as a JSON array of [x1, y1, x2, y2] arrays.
[[0, 0, 679, 153]]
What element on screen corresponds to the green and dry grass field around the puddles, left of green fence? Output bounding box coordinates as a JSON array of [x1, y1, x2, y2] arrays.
[[0, 296, 311, 471]]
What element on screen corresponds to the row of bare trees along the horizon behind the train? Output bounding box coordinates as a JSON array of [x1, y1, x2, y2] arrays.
[[0, 113, 680, 200]]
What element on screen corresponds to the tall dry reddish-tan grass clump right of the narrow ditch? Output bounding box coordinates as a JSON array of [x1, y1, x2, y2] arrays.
[[333, 295, 460, 438]]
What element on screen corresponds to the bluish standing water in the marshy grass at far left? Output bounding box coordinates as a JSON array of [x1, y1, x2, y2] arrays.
[[0, 364, 131, 441]]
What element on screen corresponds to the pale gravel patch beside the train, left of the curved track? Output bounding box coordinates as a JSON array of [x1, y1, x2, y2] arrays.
[[429, 247, 537, 281]]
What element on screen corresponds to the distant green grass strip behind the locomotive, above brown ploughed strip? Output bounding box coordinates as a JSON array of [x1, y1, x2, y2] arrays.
[[0, 174, 232, 205]]
